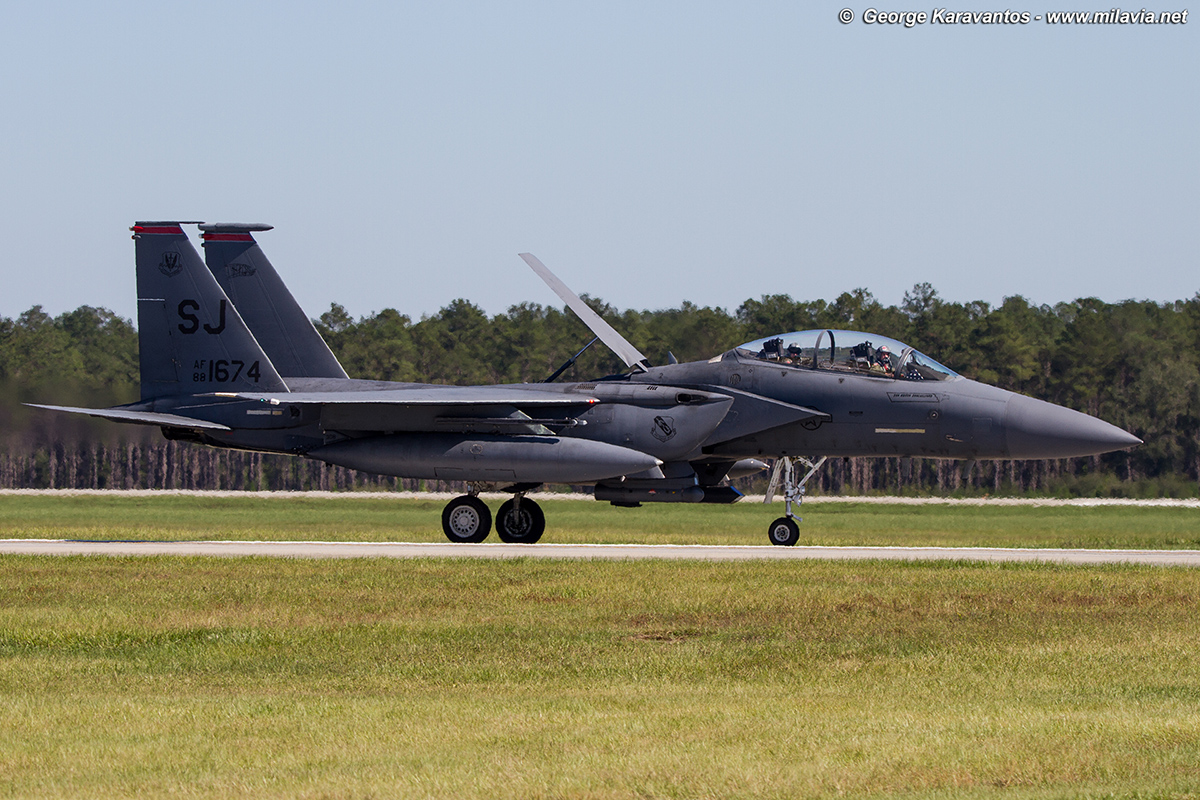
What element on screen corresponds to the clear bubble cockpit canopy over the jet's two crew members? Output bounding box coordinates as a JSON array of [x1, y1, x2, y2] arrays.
[[736, 330, 958, 380]]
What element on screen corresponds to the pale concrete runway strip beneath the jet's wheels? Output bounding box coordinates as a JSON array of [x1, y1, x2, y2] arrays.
[[0, 539, 1200, 567]]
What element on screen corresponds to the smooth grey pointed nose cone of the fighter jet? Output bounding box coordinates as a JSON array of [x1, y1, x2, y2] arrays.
[[1007, 395, 1141, 458]]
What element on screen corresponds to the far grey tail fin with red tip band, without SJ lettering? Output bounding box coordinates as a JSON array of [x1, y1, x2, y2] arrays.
[[200, 223, 347, 378]]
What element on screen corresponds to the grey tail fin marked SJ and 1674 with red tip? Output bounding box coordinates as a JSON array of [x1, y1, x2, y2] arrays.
[[131, 222, 288, 401]]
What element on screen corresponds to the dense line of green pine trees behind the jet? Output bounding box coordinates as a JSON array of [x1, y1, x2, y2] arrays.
[[0, 284, 1200, 497]]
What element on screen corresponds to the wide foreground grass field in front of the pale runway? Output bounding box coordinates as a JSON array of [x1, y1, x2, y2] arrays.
[[0, 561, 1200, 799]]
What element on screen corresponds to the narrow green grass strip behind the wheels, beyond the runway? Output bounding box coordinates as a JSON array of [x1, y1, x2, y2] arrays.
[[0, 495, 1200, 549]]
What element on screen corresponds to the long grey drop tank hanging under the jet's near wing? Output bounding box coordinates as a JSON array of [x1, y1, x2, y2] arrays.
[[307, 433, 662, 483]]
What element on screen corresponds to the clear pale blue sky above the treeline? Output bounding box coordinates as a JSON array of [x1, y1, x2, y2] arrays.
[[0, 0, 1200, 326]]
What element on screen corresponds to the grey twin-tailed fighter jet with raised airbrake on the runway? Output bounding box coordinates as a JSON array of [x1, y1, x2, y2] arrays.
[[30, 222, 1141, 545]]
